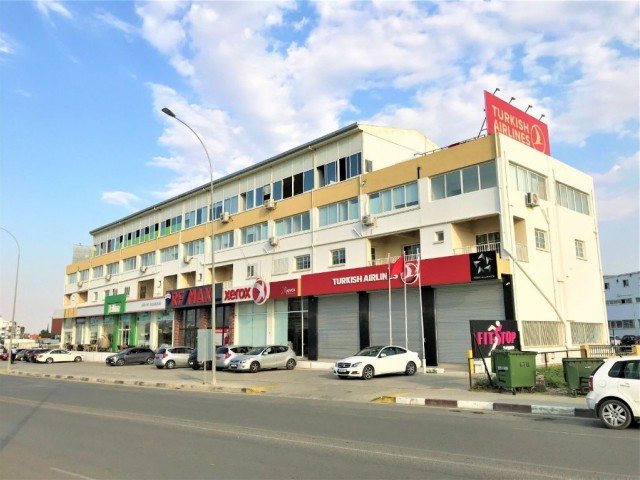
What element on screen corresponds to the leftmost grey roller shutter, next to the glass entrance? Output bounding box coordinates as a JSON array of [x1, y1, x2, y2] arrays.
[[318, 294, 360, 359]]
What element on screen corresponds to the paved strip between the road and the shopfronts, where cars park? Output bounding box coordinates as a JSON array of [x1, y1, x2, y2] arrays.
[[0, 360, 594, 418]]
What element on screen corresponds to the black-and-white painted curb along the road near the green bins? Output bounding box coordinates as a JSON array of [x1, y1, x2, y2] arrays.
[[373, 396, 596, 418]]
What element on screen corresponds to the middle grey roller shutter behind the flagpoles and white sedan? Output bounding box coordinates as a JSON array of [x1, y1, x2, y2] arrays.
[[369, 288, 422, 358]]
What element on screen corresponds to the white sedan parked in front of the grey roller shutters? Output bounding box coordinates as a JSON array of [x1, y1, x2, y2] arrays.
[[333, 345, 420, 380]]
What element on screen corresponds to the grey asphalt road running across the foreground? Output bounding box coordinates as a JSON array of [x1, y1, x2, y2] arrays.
[[0, 376, 640, 480]]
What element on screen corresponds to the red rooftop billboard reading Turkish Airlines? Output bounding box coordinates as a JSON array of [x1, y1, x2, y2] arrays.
[[484, 91, 551, 155]]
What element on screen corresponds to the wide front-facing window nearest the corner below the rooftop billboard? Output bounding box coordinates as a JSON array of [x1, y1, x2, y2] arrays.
[[431, 161, 498, 200]]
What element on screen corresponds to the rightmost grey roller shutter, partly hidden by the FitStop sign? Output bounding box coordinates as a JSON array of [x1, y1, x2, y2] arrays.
[[436, 282, 504, 364]]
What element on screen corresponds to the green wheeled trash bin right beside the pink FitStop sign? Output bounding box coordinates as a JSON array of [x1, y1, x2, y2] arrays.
[[491, 350, 538, 395]]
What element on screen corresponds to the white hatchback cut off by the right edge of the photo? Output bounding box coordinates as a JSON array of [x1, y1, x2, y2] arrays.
[[587, 356, 640, 430]]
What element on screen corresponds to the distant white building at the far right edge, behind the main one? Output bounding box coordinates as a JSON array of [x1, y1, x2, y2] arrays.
[[604, 272, 640, 338]]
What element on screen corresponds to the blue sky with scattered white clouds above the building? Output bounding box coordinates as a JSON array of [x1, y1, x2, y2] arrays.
[[0, 0, 640, 333]]
